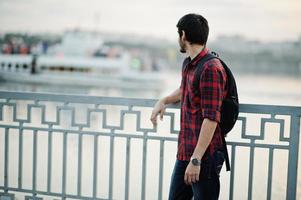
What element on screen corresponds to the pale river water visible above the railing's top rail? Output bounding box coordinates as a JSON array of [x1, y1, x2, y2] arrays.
[[0, 72, 301, 106]]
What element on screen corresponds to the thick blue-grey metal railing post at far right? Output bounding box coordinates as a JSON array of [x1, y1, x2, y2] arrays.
[[286, 113, 300, 200]]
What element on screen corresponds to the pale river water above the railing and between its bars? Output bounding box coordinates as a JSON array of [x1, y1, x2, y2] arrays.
[[0, 72, 301, 199]]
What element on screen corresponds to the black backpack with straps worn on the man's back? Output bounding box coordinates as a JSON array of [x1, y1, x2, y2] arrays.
[[193, 52, 239, 171]]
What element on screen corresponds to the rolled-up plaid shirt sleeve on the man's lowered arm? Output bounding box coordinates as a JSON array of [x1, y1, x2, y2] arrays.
[[199, 59, 227, 122]]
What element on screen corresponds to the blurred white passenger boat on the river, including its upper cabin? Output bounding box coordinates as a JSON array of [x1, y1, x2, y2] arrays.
[[0, 32, 164, 90]]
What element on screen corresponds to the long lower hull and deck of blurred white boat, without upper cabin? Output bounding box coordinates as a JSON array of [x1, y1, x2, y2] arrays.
[[0, 55, 163, 90]]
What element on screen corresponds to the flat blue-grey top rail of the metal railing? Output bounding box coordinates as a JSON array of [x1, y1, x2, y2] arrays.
[[0, 91, 301, 116]]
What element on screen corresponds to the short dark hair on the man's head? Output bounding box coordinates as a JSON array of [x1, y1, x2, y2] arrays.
[[177, 13, 209, 45]]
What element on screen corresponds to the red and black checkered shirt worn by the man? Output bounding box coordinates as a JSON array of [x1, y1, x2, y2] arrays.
[[177, 48, 227, 160]]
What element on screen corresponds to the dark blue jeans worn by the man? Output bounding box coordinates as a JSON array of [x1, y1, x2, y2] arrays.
[[168, 152, 224, 200]]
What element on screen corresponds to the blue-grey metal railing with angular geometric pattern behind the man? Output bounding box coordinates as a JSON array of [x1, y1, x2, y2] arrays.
[[0, 91, 301, 200]]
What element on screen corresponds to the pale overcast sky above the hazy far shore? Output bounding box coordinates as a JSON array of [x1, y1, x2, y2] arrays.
[[0, 0, 301, 42]]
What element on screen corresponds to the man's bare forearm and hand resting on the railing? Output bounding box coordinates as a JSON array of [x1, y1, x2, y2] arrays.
[[150, 88, 181, 126]]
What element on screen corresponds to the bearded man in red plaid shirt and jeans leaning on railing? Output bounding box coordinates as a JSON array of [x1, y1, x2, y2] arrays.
[[151, 14, 227, 200]]
